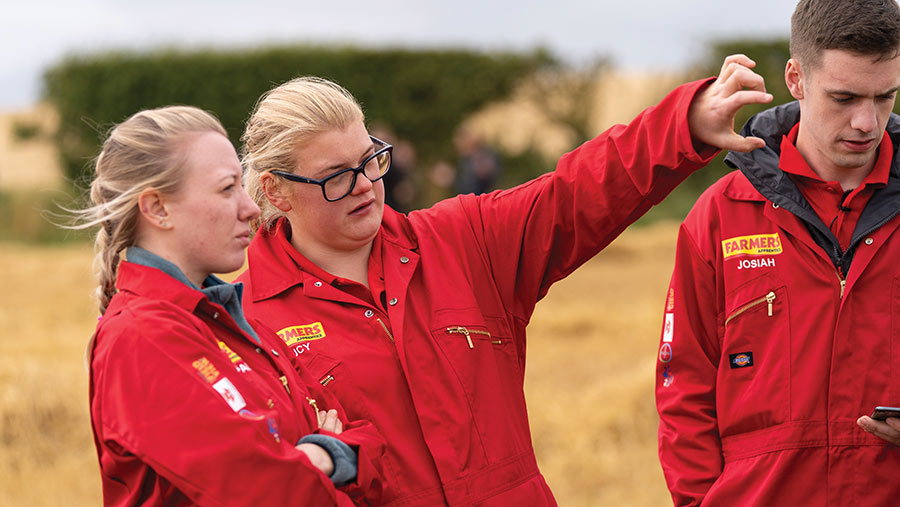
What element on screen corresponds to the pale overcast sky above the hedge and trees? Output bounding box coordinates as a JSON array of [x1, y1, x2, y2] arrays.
[[0, 0, 795, 110]]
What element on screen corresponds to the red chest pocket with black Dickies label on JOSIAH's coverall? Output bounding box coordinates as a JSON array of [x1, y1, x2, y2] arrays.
[[716, 275, 791, 436]]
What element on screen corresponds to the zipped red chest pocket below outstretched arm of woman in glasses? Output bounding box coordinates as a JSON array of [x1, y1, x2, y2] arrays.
[[431, 309, 531, 462]]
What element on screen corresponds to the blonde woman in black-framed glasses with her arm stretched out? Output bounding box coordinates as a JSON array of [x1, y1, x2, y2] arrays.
[[239, 56, 771, 507]]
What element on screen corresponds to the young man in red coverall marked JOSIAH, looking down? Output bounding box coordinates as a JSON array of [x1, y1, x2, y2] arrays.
[[656, 0, 900, 506]]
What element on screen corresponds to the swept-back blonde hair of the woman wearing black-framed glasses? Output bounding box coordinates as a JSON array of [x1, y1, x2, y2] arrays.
[[241, 76, 364, 229]]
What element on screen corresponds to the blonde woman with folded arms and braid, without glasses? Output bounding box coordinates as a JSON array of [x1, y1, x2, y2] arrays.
[[71, 106, 384, 505]]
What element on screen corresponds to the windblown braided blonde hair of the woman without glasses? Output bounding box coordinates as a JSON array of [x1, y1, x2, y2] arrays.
[[67, 106, 227, 314]]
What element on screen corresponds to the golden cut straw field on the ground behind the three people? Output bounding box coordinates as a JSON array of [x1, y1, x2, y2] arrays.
[[0, 223, 676, 506]]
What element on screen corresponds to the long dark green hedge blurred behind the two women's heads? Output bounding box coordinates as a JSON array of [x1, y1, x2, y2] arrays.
[[44, 46, 553, 182]]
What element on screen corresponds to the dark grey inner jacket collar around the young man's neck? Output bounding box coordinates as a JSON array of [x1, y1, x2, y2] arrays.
[[725, 102, 900, 276]]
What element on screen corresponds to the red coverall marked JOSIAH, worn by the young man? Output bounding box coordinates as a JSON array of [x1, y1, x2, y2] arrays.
[[656, 103, 900, 506]]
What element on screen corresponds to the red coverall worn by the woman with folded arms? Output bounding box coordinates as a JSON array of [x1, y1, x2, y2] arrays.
[[90, 262, 384, 505]]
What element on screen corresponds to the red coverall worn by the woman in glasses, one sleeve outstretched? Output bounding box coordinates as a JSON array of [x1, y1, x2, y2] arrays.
[[239, 82, 712, 507]]
